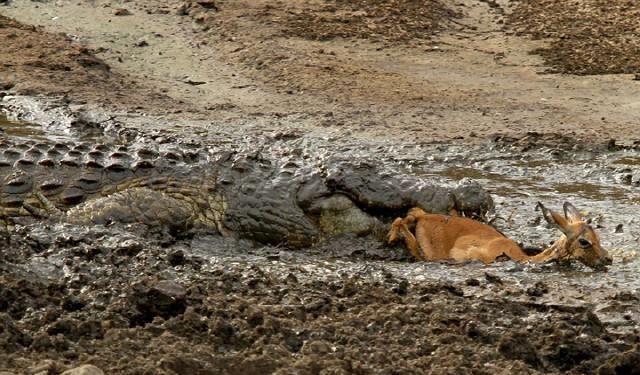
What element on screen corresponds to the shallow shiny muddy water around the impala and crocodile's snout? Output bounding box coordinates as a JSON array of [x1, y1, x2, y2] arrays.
[[0, 109, 640, 328]]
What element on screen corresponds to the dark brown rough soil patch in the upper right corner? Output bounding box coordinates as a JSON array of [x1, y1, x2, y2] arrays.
[[507, 0, 640, 74]]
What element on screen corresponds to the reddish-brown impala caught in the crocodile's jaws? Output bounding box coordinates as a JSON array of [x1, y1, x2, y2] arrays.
[[388, 203, 611, 268]]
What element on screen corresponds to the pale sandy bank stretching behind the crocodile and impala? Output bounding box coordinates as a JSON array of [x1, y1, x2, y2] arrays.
[[0, 0, 640, 143]]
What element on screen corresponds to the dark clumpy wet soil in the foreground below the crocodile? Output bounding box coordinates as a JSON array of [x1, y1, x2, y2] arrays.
[[0, 229, 640, 375]]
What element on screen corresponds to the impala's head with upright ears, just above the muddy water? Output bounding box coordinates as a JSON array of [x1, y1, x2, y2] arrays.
[[537, 202, 612, 269]]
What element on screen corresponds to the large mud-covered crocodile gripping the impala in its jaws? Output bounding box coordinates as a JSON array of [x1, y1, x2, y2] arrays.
[[0, 138, 493, 248]]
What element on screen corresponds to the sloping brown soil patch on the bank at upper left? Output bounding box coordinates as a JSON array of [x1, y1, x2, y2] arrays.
[[0, 15, 178, 111]]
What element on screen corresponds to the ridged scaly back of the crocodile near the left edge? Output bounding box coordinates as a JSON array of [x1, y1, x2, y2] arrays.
[[0, 140, 205, 216]]
